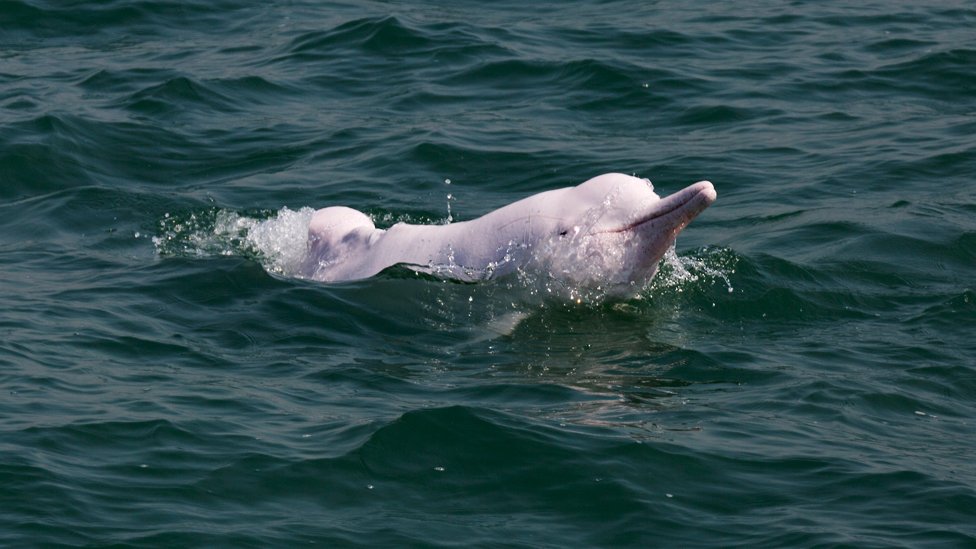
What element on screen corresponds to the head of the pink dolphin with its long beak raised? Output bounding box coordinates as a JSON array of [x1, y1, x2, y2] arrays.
[[534, 174, 716, 294]]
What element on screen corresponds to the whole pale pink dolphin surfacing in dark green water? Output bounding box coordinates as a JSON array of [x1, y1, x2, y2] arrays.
[[302, 173, 716, 293]]
